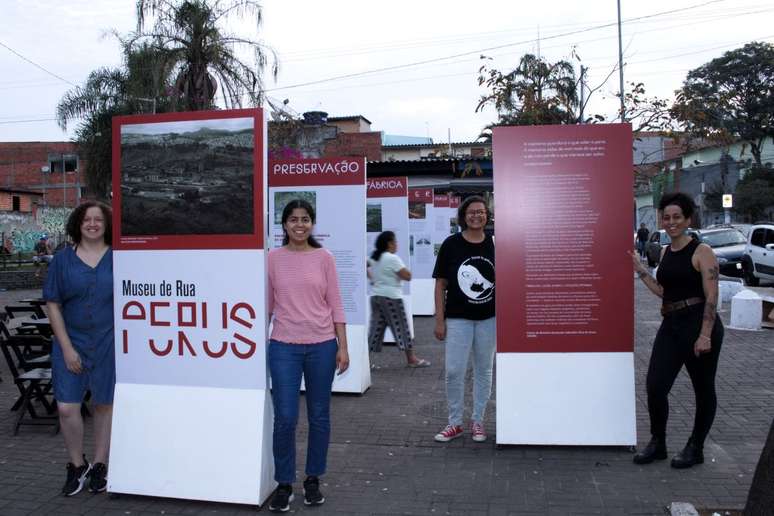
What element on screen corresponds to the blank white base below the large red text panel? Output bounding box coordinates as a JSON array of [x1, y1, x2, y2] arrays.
[[497, 353, 637, 446]]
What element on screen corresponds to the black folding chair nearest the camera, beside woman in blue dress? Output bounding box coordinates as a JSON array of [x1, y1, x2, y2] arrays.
[[0, 338, 59, 435]]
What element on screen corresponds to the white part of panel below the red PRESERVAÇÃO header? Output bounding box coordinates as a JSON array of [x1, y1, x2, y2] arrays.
[[268, 184, 371, 394]]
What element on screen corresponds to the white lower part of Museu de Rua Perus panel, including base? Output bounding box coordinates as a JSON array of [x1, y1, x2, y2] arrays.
[[108, 249, 276, 504]]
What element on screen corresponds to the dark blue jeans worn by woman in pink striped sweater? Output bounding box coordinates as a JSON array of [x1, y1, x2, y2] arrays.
[[269, 339, 338, 484]]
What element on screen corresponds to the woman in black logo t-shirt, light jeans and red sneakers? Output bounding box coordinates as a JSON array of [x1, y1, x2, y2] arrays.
[[433, 195, 495, 442]]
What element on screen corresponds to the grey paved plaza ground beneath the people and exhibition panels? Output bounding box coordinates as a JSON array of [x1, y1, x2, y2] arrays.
[[0, 282, 774, 516]]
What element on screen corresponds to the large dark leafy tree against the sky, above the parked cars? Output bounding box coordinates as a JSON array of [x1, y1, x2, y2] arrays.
[[672, 42, 774, 167]]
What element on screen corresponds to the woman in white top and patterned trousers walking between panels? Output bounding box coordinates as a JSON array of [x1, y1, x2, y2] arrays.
[[368, 231, 430, 367]]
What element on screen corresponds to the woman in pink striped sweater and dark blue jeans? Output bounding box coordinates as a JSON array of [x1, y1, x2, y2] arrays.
[[268, 199, 349, 512]]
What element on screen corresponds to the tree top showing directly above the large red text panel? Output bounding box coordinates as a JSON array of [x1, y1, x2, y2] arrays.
[[476, 54, 579, 137]]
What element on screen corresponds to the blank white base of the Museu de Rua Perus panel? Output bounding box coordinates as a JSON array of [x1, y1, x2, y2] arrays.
[[108, 383, 276, 505]]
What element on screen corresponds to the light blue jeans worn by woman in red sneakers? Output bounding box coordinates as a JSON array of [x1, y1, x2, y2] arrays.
[[446, 317, 495, 425]]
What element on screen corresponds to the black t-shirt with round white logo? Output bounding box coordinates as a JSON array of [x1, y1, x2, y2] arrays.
[[433, 233, 495, 321]]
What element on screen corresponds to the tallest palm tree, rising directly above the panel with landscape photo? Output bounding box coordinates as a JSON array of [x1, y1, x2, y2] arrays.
[[129, 0, 278, 111]]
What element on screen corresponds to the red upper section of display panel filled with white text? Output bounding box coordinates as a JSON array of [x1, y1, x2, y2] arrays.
[[493, 124, 634, 353]]
